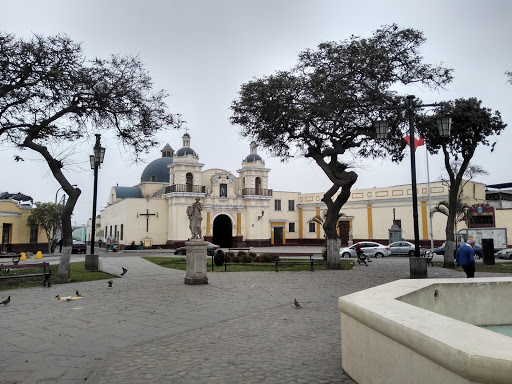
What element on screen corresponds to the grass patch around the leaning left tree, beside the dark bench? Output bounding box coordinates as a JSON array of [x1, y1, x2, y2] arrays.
[[0, 261, 114, 291]]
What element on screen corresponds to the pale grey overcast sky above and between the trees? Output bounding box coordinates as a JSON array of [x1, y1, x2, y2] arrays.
[[0, 0, 512, 225]]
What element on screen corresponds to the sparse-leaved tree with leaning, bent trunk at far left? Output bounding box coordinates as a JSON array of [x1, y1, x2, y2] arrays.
[[0, 32, 181, 280]]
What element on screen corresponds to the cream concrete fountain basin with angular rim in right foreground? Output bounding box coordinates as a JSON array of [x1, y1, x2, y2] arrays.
[[338, 277, 512, 384]]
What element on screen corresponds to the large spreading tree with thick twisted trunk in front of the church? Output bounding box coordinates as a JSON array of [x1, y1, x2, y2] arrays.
[[231, 25, 452, 268]]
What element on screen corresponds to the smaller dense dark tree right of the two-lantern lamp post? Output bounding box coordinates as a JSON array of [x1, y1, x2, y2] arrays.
[[417, 98, 507, 268]]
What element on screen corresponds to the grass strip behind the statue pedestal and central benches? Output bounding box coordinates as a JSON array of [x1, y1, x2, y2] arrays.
[[144, 257, 354, 272]]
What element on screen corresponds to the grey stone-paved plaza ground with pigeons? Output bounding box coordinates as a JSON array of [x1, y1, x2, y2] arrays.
[[0, 255, 508, 384]]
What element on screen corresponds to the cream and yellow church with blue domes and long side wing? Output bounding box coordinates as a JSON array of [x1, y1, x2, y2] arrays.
[[87, 133, 498, 248]]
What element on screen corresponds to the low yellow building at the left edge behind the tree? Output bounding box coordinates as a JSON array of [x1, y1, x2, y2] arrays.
[[0, 193, 48, 253]]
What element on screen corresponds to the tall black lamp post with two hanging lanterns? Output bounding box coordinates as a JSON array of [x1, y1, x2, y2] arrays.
[[374, 95, 452, 274]]
